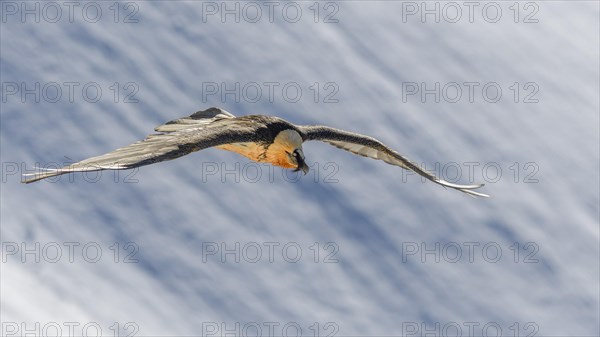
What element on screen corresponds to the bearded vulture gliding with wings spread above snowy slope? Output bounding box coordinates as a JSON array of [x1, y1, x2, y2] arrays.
[[22, 108, 488, 197]]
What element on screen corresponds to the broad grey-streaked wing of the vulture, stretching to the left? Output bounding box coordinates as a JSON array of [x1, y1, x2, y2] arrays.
[[22, 108, 257, 183]]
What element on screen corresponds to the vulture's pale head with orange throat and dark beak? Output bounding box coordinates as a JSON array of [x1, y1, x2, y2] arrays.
[[267, 130, 310, 174]]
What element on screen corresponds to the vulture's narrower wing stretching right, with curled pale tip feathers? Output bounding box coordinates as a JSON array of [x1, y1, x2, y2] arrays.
[[298, 126, 488, 197]]
